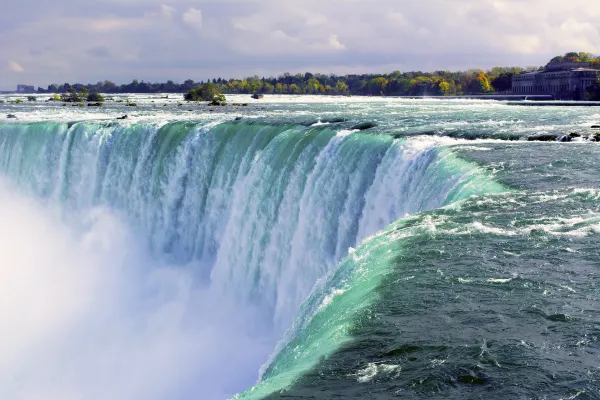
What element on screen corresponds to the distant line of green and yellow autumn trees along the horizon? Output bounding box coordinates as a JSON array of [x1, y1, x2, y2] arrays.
[[38, 52, 600, 96]]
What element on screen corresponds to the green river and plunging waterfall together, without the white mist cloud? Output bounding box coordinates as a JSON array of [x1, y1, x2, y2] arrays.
[[0, 97, 600, 399]]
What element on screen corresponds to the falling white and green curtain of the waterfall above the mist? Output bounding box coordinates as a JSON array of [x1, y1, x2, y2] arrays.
[[0, 122, 504, 396]]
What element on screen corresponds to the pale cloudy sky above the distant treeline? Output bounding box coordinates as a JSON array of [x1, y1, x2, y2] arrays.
[[0, 0, 600, 90]]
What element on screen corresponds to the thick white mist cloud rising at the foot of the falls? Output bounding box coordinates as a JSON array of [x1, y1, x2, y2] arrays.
[[0, 177, 274, 400]]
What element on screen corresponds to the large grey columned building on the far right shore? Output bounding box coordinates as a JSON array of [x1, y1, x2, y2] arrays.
[[512, 62, 600, 100]]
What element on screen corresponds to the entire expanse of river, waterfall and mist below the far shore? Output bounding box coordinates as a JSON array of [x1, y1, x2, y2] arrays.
[[0, 96, 600, 399]]
